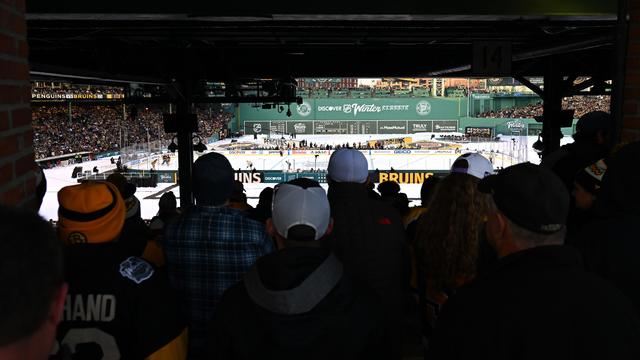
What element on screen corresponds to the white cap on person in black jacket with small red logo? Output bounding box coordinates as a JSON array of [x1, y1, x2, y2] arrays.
[[327, 149, 369, 183]]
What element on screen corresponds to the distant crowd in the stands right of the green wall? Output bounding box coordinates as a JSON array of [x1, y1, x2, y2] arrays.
[[476, 95, 610, 119]]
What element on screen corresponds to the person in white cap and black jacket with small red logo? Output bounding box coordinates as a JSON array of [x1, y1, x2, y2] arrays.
[[327, 149, 409, 358]]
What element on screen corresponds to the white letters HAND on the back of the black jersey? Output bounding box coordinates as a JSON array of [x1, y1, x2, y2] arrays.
[[63, 294, 116, 322]]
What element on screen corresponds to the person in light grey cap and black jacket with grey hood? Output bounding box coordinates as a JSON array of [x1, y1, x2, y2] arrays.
[[209, 178, 389, 359]]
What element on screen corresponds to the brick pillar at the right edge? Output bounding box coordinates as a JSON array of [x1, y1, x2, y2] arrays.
[[621, 0, 640, 141]]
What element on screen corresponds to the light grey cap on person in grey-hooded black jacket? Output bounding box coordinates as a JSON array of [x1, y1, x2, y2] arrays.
[[271, 183, 331, 240]]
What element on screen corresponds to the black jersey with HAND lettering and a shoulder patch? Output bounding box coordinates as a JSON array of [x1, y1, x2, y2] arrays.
[[54, 243, 187, 360]]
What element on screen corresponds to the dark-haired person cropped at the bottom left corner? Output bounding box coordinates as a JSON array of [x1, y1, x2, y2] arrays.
[[0, 205, 67, 360]]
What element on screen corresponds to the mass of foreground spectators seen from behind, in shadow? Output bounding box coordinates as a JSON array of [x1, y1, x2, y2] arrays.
[[5, 108, 640, 360]]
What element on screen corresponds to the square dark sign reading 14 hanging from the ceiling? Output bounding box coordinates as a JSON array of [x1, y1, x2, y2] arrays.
[[471, 41, 511, 76]]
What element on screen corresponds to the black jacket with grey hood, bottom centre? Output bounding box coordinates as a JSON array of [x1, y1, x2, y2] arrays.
[[209, 248, 389, 359]]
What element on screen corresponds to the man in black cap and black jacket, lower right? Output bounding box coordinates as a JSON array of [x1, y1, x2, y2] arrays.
[[428, 163, 640, 360]]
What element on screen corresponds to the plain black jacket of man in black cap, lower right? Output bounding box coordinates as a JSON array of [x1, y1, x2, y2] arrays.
[[428, 246, 640, 360]]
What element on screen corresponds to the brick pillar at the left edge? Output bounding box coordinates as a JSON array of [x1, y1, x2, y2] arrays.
[[0, 0, 35, 206]]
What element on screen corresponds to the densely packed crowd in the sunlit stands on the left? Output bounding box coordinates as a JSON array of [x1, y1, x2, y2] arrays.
[[32, 104, 232, 159]]
